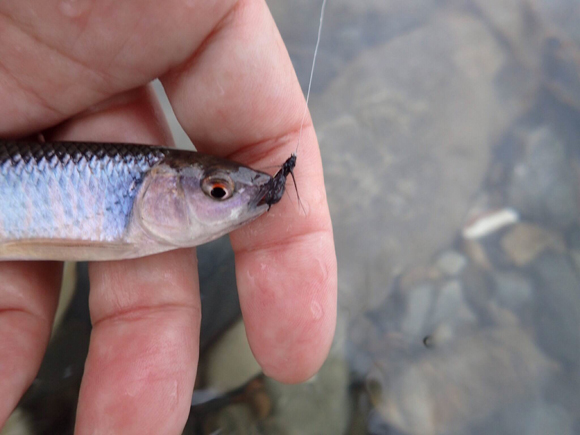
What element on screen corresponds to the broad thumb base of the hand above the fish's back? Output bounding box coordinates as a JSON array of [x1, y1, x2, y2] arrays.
[[0, 0, 235, 136]]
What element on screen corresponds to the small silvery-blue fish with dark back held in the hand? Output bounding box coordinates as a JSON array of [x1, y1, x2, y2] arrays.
[[0, 141, 296, 261]]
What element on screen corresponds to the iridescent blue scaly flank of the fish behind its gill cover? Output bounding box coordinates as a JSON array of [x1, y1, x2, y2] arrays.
[[0, 142, 166, 242]]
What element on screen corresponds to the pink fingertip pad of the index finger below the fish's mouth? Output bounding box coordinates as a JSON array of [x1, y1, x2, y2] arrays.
[[236, 232, 336, 384]]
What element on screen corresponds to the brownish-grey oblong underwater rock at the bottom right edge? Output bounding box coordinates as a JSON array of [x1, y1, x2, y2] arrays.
[[371, 328, 555, 435]]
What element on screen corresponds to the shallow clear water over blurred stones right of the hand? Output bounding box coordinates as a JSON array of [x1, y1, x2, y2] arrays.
[[6, 0, 580, 435]]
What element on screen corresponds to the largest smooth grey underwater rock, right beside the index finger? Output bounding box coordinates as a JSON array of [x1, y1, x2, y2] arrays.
[[311, 13, 529, 308]]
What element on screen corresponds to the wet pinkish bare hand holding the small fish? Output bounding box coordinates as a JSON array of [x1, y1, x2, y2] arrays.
[[0, 0, 337, 434]]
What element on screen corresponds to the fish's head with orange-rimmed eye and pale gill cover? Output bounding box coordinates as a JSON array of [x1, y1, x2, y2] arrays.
[[138, 155, 273, 247]]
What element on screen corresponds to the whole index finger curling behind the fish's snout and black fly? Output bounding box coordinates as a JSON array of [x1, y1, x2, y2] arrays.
[[162, 0, 336, 382]]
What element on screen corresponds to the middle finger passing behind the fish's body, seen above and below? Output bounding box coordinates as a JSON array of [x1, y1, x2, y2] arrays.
[[46, 86, 201, 434]]
